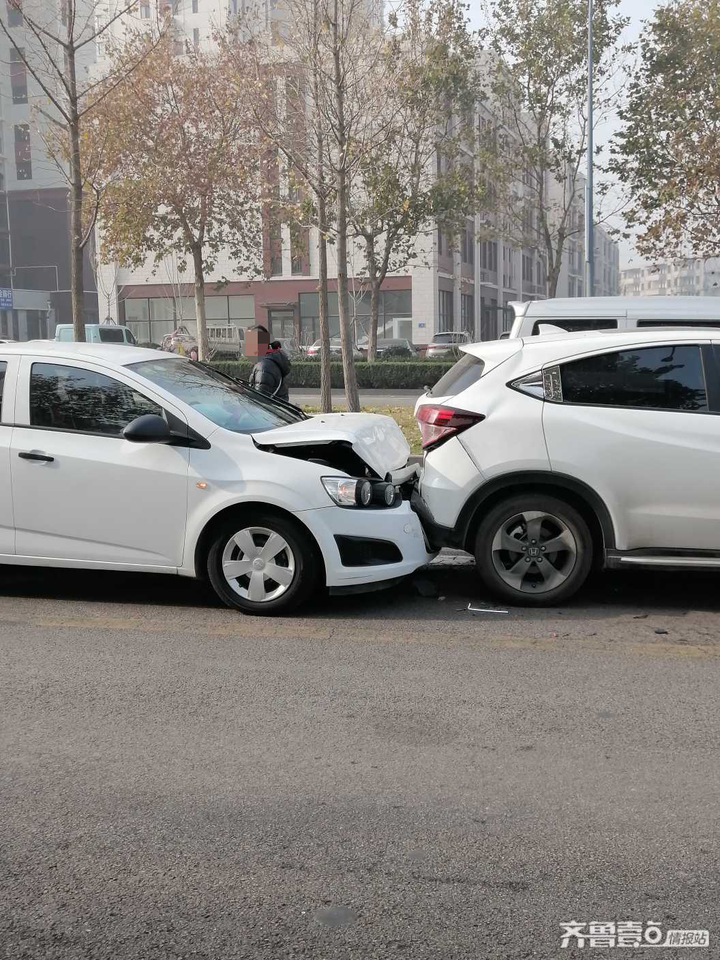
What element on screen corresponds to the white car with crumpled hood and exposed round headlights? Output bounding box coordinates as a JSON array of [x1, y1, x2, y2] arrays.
[[0, 341, 429, 614]]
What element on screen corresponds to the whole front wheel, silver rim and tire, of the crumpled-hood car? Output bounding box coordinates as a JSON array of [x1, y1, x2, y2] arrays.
[[207, 514, 320, 616]]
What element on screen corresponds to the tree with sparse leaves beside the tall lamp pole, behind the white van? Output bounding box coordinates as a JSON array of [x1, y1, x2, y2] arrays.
[[479, 0, 628, 297]]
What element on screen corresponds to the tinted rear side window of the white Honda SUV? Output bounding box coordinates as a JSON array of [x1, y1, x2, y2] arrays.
[[560, 344, 708, 411]]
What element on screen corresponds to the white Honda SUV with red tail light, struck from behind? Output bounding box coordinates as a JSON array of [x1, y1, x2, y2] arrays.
[[415, 329, 720, 605]]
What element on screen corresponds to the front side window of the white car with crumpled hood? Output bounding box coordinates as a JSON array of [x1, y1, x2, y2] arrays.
[[30, 363, 163, 437]]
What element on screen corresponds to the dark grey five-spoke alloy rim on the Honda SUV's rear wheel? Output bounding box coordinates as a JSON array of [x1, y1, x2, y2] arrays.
[[492, 510, 578, 594]]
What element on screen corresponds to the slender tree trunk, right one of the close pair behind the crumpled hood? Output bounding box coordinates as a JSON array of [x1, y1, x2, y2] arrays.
[[333, 0, 360, 413]]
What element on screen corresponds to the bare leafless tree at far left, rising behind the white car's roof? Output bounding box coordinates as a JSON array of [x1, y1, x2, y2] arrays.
[[0, 0, 166, 340]]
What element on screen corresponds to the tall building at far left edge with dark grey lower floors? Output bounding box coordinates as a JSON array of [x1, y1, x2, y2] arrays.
[[0, 0, 97, 340]]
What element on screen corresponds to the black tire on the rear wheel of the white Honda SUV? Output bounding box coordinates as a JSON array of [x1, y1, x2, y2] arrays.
[[475, 493, 593, 607]]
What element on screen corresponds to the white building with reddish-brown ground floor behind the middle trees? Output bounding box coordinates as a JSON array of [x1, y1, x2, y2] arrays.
[[93, 0, 618, 344]]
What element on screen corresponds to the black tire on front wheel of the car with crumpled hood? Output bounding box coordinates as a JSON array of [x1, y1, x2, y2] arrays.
[[207, 512, 322, 617]]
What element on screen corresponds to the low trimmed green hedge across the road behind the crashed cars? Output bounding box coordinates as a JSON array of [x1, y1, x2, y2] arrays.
[[212, 360, 453, 390]]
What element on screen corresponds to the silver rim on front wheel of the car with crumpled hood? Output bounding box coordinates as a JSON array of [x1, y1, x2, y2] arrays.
[[222, 527, 296, 603]]
